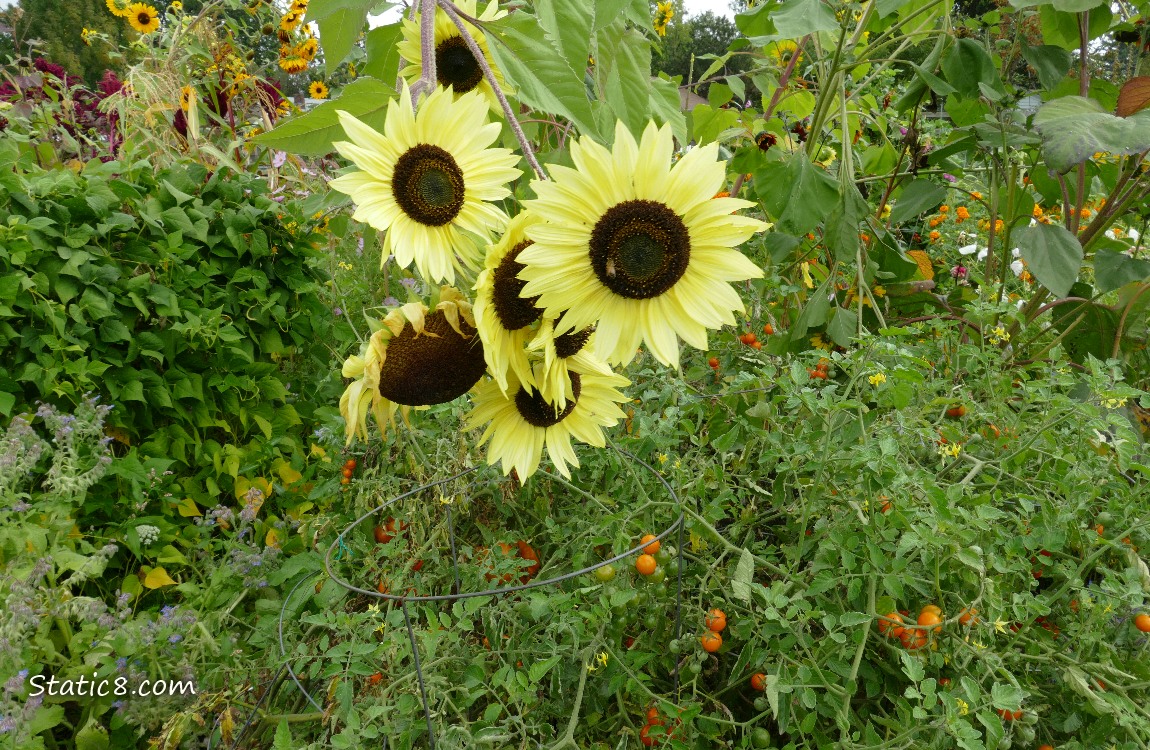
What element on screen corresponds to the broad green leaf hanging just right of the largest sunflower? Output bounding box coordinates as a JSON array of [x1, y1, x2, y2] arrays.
[[753, 152, 838, 236]]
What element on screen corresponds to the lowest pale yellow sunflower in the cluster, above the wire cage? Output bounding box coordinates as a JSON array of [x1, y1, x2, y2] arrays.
[[467, 356, 630, 481]]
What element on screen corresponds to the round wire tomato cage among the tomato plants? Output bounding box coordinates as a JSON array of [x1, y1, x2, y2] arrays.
[[264, 445, 684, 749]]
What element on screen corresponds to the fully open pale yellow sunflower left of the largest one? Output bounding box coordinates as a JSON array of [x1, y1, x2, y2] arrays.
[[331, 85, 521, 283]]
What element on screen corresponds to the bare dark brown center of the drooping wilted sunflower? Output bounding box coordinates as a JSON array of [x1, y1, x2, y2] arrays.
[[380, 309, 486, 406]]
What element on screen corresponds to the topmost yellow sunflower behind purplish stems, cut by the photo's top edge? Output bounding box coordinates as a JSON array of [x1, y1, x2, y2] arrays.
[[397, 0, 514, 112]]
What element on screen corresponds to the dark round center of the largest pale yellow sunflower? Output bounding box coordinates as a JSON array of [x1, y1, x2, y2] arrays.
[[590, 200, 691, 299]]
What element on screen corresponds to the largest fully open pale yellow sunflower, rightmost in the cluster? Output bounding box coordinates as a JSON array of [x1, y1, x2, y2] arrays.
[[519, 123, 767, 367]]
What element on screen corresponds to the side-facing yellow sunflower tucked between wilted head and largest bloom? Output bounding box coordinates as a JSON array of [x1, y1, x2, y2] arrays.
[[475, 212, 543, 392]]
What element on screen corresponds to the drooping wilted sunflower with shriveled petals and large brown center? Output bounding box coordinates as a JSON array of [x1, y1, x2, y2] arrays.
[[339, 286, 486, 444]]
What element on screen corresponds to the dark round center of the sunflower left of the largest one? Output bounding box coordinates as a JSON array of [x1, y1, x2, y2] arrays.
[[391, 144, 463, 227]]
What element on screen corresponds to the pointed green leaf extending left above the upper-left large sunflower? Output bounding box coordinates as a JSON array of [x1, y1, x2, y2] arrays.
[[255, 77, 396, 156]]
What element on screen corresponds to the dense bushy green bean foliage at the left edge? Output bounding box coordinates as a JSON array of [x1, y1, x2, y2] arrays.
[[0, 141, 334, 499]]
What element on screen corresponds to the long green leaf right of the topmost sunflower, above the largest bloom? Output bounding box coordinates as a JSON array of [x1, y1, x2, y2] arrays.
[[485, 10, 599, 137]]
